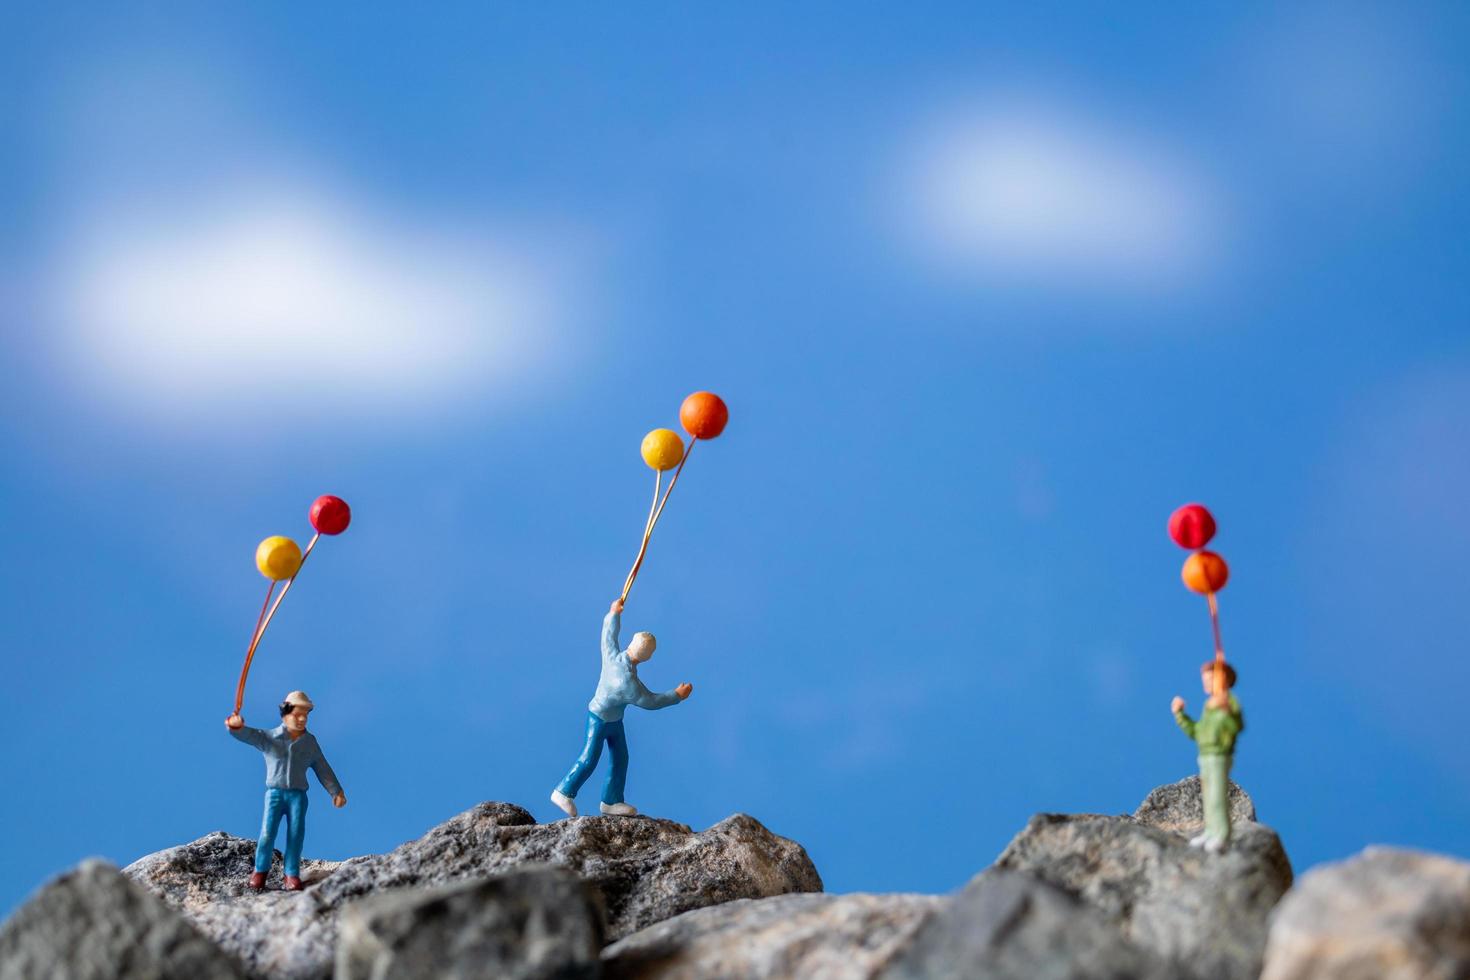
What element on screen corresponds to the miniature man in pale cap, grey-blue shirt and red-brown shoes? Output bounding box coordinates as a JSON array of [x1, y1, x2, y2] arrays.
[[225, 691, 347, 892]]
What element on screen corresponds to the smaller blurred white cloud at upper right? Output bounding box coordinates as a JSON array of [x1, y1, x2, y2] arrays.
[[906, 100, 1220, 296]]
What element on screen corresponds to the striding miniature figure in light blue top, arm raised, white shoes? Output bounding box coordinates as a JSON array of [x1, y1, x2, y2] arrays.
[[551, 599, 694, 817]]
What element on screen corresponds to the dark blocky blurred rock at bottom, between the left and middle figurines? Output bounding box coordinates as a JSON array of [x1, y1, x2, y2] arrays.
[[334, 867, 604, 980]]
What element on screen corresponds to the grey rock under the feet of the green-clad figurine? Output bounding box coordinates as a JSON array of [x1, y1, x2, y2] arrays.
[[995, 814, 1292, 980]]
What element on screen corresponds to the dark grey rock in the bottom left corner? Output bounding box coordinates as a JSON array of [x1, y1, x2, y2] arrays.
[[0, 860, 244, 980]]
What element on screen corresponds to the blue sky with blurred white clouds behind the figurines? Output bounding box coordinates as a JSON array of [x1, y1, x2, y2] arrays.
[[0, 4, 1470, 908]]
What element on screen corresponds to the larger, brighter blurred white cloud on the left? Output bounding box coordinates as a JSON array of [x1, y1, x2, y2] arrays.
[[50, 185, 551, 411]]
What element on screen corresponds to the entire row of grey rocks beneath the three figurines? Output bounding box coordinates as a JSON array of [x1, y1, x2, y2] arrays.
[[14, 777, 1470, 980]]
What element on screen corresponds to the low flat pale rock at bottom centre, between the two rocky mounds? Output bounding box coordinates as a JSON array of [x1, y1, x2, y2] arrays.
[[603, 895, 945, 980]]
